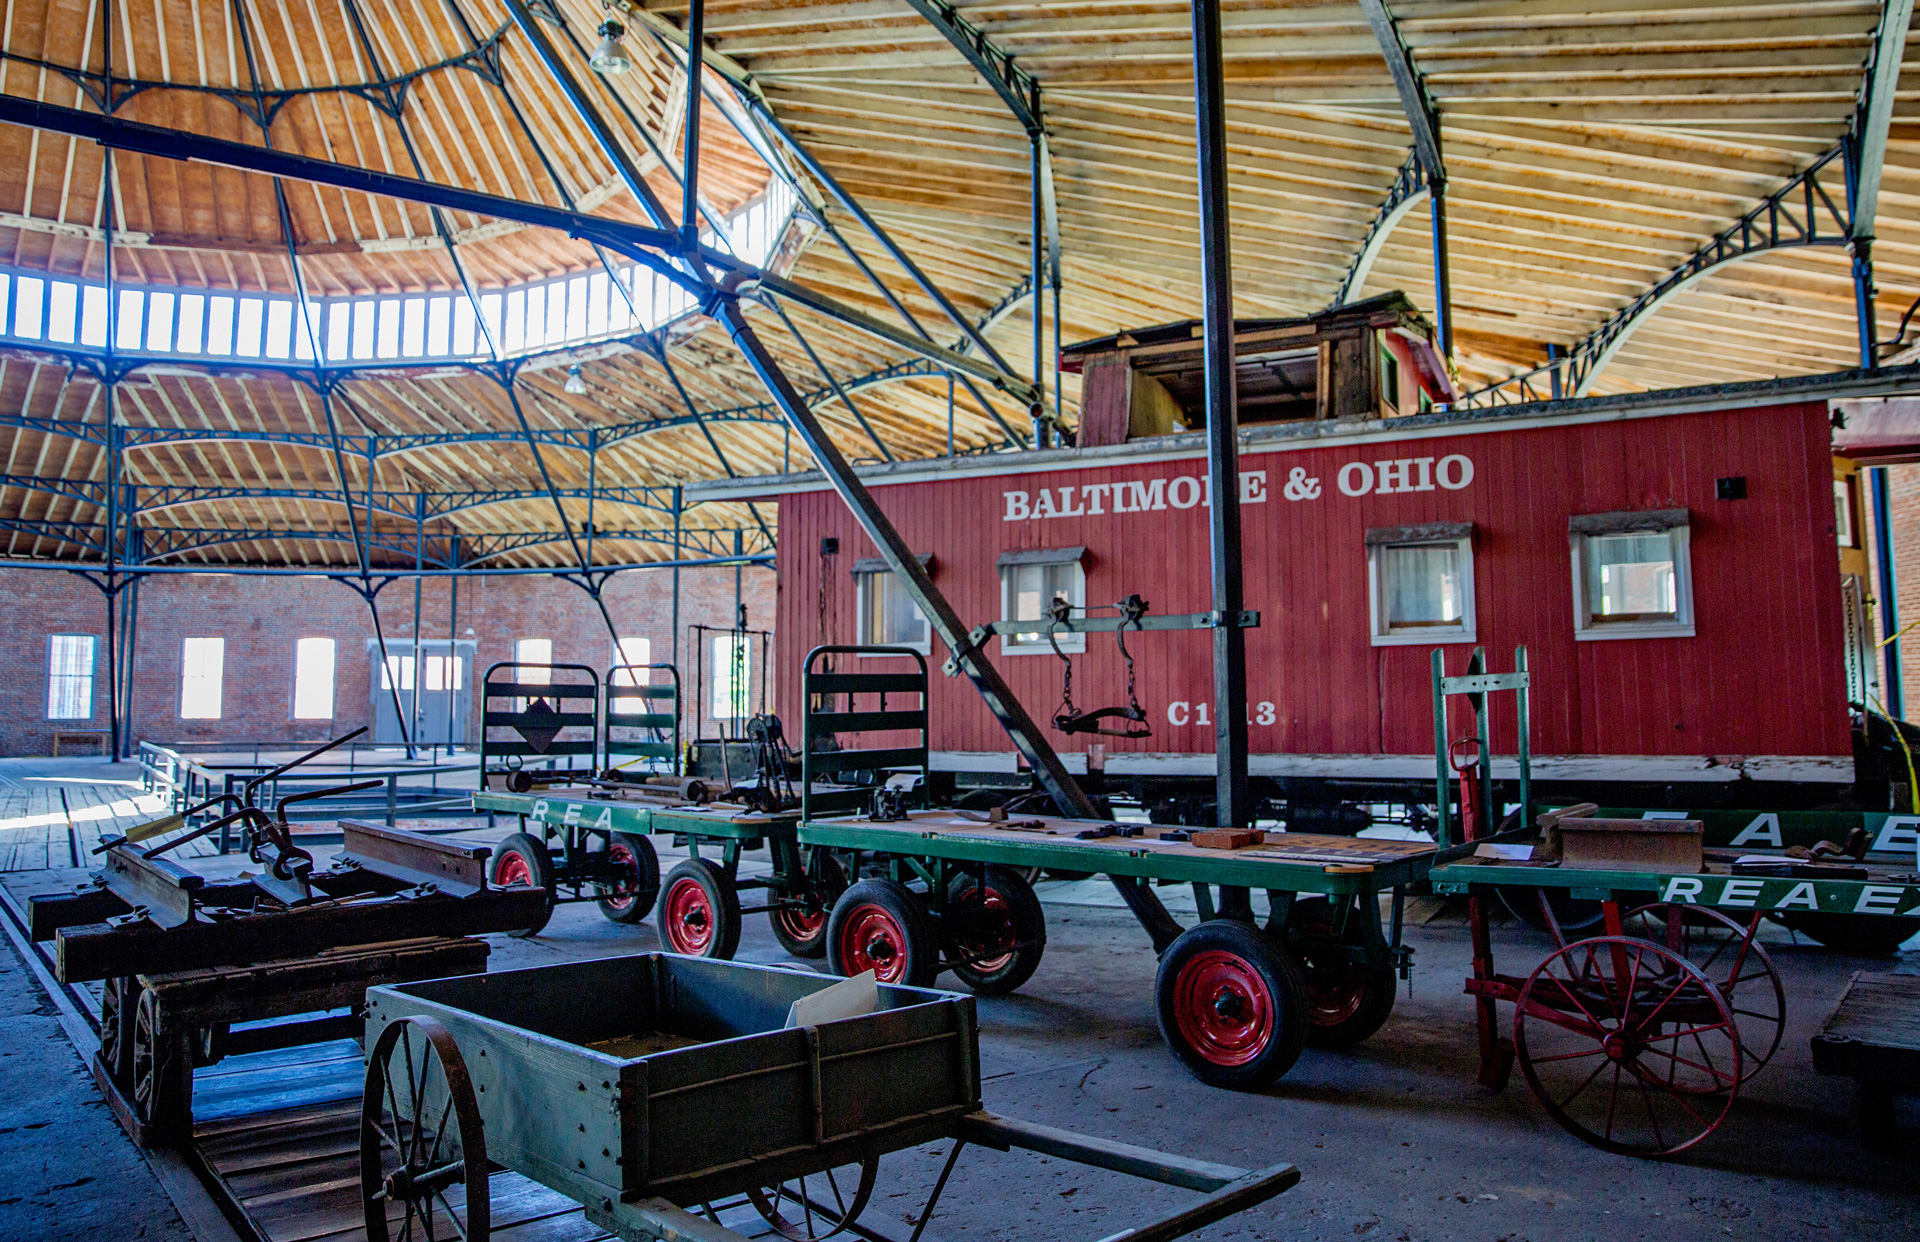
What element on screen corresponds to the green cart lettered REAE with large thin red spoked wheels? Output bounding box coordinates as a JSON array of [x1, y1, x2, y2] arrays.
[[1428, 649, 1920, 1158]]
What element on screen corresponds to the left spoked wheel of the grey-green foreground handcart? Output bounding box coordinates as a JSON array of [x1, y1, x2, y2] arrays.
[[361, 1017, 490, 1242]]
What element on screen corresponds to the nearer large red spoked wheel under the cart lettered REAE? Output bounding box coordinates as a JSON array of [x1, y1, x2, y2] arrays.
[[1513, 937, 1741, 1156]]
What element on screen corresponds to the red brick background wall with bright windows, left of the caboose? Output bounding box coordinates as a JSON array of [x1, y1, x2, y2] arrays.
[[0, 566, 774, 756]]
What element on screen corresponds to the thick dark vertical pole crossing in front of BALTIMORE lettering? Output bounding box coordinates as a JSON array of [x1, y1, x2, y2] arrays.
[[1190, 0, 1252, 827]]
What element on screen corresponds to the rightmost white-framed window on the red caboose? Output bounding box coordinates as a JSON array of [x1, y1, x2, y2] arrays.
[[1569, 509, 1693, 639]]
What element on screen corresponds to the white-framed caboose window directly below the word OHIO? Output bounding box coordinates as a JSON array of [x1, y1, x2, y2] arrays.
[[1367, 522, 1475, 647]]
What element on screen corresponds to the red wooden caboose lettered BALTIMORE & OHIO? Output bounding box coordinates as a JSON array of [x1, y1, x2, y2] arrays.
[[699, 298, 1874, 829]]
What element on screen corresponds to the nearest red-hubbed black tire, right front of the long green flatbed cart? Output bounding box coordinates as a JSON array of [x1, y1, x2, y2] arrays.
[[1154, 920, 1308, 1090]]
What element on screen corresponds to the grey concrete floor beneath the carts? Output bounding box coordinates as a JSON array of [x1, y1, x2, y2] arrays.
[[0, 756, 1920, 1242]]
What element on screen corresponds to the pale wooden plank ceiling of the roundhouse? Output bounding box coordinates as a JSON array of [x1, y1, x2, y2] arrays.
[[0, 0, 1920, 564]]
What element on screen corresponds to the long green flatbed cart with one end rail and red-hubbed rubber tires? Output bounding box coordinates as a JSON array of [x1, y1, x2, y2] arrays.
[[799, 647, 1436, 1088]]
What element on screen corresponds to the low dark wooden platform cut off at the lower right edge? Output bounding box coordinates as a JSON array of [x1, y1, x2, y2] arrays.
[[1812, 971, 1920, 1152]]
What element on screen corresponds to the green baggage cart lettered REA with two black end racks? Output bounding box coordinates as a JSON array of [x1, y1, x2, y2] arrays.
[[474, 662, 864, 958]]
